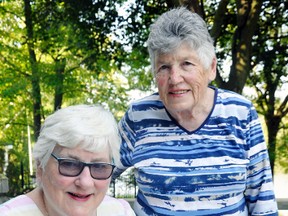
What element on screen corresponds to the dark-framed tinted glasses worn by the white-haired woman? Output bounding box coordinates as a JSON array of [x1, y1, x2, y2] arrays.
[[51, 153, 115, 180]]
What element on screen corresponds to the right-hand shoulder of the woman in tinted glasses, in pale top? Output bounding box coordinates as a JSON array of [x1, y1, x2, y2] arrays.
[[97, 196, 135, 216]]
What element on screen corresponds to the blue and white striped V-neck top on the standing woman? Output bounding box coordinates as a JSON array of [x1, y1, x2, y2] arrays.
[[116, 87, 278, 216]]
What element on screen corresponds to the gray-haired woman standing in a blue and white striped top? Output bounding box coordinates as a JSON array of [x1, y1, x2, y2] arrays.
[[114, 7, 277, 216]]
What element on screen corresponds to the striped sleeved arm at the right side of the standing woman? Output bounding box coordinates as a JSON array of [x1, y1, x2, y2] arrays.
[[244, 106, 278, 216]]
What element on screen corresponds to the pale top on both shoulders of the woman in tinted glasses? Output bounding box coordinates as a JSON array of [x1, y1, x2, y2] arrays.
[[0, 195, 135, 216]]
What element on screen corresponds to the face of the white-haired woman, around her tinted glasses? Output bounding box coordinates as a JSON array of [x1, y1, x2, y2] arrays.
[[37, 145, 111, 216]]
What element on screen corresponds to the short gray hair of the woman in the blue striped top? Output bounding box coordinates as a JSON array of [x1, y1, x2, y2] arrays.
[[147, 7, 215, 75]]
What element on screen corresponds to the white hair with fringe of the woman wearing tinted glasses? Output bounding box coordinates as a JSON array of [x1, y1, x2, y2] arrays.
[[33, 105, 120, 169]]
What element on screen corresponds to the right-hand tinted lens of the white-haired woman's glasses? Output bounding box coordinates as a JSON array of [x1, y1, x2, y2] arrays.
[[90, 163, 114, 179]]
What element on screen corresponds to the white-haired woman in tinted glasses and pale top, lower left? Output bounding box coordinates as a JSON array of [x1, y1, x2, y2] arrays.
[[0, 105, 135, 216]]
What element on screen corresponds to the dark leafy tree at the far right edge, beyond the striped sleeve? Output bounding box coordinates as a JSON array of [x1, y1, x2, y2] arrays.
[[248, 1, 288, 175]]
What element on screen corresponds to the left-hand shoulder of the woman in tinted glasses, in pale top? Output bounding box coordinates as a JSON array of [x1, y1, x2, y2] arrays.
[[0, 195, 42, 216]]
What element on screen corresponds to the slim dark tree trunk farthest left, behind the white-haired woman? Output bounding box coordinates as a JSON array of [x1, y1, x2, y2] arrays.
[[24, 0, 41, 140]]
